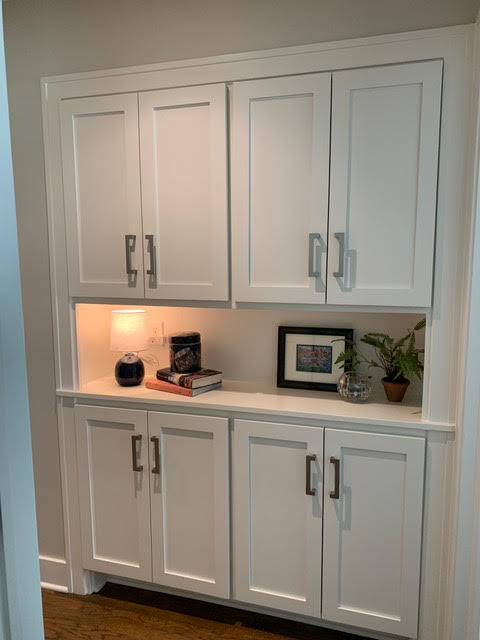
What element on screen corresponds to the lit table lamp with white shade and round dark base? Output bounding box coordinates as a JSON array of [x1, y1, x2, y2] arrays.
[[110, 309, 148, 387]]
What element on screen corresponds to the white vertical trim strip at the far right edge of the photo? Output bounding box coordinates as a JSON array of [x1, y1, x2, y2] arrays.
[[447, 19, 480, 640]]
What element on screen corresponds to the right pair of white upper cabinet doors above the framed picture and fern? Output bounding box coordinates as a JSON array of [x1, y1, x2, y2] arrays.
[[232, 61, 442, 307]]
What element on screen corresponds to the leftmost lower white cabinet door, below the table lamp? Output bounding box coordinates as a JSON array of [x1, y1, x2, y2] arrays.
[[75, 406, 152, 581]]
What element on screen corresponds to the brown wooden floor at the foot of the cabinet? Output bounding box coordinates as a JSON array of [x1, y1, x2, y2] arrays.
[[43, 583, 368, 640]]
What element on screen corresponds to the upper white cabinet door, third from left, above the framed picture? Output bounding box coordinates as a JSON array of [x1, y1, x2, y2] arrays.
[[232, 73, 331, 304]]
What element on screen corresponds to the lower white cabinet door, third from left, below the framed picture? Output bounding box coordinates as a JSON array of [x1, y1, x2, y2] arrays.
[[233, 420, 323, 616]]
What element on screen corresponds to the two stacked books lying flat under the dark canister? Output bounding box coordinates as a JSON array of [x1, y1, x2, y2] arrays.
[[145, 368, 222, 398]]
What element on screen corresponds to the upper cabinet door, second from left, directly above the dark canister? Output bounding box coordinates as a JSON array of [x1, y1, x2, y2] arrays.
[[139, 84, 229, 300]]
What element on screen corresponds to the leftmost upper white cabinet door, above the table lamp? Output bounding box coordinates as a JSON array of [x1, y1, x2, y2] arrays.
[[61, 94, 144, 298]]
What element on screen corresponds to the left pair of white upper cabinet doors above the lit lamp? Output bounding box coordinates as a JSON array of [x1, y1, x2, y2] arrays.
[[60, 83, 229, 301]]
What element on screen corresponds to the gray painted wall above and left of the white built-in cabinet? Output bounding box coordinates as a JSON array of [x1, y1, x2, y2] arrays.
[[4, 0, 478, 557]]
